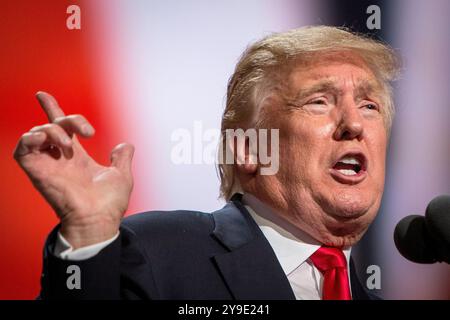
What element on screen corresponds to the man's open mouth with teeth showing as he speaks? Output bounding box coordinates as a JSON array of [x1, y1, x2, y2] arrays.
[[330, 153, 367, 184]]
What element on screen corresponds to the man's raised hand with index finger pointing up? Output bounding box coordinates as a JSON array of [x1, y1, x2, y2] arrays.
[[14, 92, 134, 248]]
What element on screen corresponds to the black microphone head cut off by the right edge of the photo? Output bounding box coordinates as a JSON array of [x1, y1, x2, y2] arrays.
[[425, 195, 450, 262]]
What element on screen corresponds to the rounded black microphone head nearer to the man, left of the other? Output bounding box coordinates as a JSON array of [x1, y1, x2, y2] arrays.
[[394, 215, 437, 263]]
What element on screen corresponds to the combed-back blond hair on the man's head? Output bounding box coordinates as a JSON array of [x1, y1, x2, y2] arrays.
[[218, 26, 400, 200]]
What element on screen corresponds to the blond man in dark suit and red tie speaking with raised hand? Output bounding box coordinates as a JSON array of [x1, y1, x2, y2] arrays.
[[14, 26, 398, 300]]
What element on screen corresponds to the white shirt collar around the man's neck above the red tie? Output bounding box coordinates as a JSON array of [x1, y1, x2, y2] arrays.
[[242, 193, 351, 275]]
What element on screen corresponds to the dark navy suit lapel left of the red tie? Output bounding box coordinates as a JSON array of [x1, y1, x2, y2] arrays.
[[212, 196, 295, 300]]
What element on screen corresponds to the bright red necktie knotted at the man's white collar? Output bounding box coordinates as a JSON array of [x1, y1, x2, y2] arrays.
[[309, 247, 352, 300]]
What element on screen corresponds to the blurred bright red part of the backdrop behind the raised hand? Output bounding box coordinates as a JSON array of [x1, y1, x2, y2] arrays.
[[0, 1, 132, 299]]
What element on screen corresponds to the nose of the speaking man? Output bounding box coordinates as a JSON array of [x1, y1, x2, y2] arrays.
[[334, 99, 364, 140]]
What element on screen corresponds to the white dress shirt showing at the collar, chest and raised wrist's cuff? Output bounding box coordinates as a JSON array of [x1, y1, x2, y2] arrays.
[[54, 193, 351, 300]]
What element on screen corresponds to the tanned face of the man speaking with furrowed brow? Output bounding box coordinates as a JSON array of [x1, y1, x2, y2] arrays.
[[244, 54, 387, 246]]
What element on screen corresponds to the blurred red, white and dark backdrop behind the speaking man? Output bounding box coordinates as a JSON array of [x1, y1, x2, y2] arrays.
[[0, 0, 450, 299]]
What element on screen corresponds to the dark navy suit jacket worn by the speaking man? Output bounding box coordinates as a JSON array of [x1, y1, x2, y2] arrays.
[[40, 195, 373, 299]]
